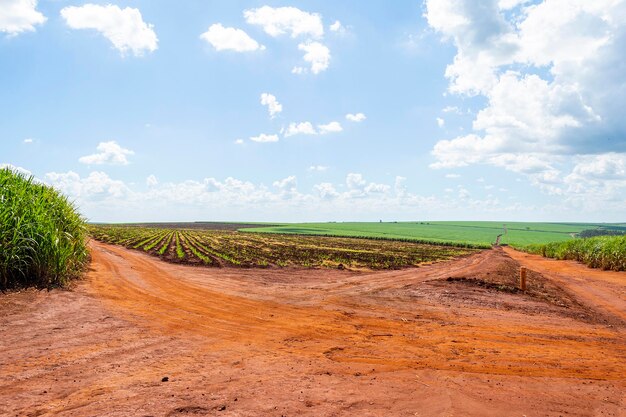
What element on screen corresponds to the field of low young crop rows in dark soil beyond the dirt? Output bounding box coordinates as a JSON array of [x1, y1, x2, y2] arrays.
[[89, 225, 475, 269]]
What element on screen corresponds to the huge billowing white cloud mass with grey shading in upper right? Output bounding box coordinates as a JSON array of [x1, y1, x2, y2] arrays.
[[425, 0, 626, 203]]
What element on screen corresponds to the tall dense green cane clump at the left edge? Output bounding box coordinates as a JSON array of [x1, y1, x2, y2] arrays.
[[0, 168, 89, 290]]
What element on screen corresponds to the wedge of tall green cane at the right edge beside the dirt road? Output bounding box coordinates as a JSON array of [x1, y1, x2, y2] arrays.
[[522, 236, 626, 271]]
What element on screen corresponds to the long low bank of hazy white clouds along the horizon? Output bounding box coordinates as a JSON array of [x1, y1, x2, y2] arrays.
[[34, 166, 626, 222]]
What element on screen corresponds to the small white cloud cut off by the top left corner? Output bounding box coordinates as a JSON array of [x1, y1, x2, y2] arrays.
[[0, 0, 47, 36]]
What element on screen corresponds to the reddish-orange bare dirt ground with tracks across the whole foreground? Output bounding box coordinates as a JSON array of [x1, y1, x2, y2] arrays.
[[0, 242, 626, 416]]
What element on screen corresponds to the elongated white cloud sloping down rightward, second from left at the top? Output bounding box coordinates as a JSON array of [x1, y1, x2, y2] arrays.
[[61, 4, 158, 56]]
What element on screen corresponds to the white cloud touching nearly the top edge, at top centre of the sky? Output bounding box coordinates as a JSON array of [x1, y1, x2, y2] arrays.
[[243, 6, 324, 38]]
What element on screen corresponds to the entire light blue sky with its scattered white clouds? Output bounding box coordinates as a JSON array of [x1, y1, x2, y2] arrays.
[[0, 0, 626, 221]]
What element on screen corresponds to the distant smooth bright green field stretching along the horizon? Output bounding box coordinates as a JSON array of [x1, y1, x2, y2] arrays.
[[242, 221, 624, 246]]
